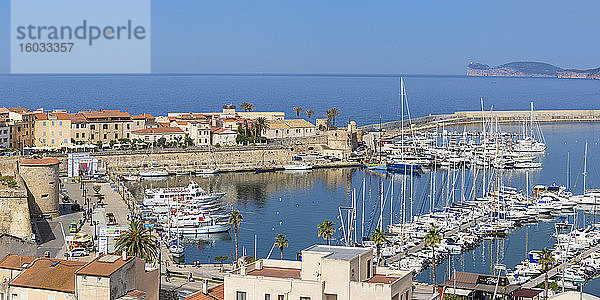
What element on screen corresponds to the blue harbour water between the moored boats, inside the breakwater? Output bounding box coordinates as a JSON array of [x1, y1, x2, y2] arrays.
[[127, 124, 598, 296]]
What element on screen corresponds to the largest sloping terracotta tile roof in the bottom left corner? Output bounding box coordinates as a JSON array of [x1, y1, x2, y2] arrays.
[[9, 258, 86, 293]]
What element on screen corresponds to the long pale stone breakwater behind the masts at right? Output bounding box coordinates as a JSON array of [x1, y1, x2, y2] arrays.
[[360, 110, 600, 137]]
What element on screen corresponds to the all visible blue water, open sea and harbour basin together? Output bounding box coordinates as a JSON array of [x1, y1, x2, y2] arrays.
[[0, 75, 600, 294]]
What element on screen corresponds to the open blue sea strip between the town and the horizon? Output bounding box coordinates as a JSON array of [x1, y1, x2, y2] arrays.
[[0, 75, 600, 125]]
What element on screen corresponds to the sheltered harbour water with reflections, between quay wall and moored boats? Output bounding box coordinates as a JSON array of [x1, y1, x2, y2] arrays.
[[130, 124, 600, 292]]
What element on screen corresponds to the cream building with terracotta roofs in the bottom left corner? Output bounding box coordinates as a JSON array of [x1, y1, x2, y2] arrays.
[[0, 255, 159, 300]]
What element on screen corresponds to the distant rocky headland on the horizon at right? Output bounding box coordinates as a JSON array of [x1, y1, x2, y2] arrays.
[[467, 61, 600, 80]]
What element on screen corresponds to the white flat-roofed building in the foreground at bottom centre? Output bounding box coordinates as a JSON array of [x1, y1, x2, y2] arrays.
[[224, 245, 412, 300]]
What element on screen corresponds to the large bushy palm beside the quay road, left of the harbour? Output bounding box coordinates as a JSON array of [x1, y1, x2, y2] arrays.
[[116, 219, 160, 262]]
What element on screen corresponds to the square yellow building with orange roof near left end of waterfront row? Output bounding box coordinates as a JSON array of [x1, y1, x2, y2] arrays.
[[33, 111, 72, 148]]
